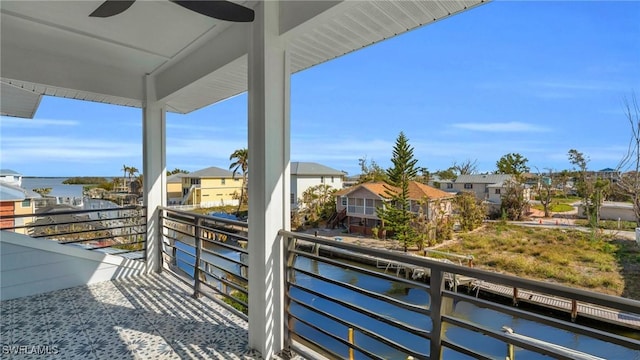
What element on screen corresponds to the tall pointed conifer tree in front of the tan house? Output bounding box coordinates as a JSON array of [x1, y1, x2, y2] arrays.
[[377, 132, 418, 252]]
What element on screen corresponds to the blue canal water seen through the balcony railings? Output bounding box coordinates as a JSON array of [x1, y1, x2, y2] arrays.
[[177, 244, 640, 360]]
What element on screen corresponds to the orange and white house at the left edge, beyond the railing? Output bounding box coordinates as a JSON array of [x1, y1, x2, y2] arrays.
[[0, 181, 41, 234]]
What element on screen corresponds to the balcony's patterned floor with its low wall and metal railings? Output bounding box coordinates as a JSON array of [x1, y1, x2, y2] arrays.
[[1, 207, 640, 359]]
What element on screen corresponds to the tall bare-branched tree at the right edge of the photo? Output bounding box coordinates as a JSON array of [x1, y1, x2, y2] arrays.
[[615, 93, 640, 226]]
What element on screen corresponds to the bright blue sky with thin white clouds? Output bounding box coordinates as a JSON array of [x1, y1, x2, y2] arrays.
[[0, 1, 640, 176]]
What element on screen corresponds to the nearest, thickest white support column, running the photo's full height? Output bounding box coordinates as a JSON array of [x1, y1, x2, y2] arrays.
[[248, 1, 291, 359]]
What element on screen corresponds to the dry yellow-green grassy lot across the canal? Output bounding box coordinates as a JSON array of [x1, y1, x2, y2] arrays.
[[438, 223, 640, 299]]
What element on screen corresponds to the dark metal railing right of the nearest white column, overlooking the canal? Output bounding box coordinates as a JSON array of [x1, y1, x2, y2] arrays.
[[280, 231, 640, 360]]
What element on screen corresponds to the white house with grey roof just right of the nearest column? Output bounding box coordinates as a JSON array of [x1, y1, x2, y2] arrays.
[[291, 161, 345, 209]]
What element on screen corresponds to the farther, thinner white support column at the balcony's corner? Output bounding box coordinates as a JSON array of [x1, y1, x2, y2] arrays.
[[142, 75, 167, 272]]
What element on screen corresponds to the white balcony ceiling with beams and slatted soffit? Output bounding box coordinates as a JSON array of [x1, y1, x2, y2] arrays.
[[0, 0, 483, 117]]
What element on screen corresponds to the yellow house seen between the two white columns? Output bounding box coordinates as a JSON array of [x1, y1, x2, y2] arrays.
[[181, 166, 242, 207]]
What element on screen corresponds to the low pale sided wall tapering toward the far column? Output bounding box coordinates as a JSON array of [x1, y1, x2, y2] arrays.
[[0, 231, 145, 300]]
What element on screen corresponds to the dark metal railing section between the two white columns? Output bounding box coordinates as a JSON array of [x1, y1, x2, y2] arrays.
[[159, 207, 249, 320]]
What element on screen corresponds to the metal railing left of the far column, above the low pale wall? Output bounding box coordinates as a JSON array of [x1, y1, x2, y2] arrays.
[[0, 206, 147, 260]]
